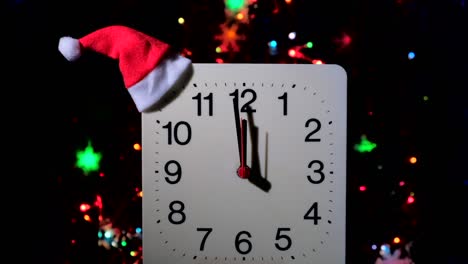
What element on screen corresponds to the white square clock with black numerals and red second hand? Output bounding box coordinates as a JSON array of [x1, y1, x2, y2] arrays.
[[142, 64, 347, 264]]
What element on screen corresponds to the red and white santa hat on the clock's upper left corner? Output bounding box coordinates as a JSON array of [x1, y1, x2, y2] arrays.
[[58, 25, 191, 112]]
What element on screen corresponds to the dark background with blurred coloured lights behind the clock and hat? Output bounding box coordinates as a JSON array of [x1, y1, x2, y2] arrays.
[[9, 0, 468, 264]]
